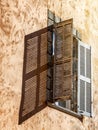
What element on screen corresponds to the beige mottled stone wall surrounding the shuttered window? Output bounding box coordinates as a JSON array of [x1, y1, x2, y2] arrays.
[[0, 0, 98, 130]]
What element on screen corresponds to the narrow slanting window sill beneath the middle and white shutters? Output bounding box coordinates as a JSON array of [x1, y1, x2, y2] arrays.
[[48, 102, 83, 121]]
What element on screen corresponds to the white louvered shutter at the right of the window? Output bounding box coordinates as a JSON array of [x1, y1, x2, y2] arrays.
[[78, 41, 92, 116]]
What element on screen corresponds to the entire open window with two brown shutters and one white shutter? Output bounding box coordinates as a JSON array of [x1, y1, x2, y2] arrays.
[[19, 17, 92, 124]]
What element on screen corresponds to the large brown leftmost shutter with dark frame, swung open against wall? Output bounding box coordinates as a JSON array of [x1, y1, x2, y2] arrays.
[[19, 28, 47, 124]]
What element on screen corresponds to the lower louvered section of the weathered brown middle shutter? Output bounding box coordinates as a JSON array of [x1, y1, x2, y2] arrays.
[[55, 63, 72, 99]]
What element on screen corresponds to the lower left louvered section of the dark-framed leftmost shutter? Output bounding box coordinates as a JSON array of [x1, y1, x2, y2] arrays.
[[22, 76, 37, 116]]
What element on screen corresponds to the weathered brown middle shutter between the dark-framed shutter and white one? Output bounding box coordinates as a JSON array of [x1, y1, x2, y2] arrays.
[[53, 19, 73, 100]]
